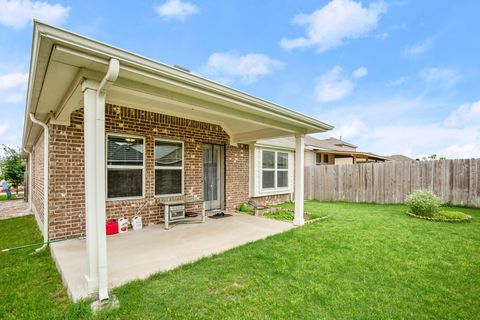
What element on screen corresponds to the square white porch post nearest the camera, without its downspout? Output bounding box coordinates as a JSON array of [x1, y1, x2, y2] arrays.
[[82, 81, 98, 294]]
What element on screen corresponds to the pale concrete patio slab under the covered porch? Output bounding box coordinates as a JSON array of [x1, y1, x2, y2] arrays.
[[51, 214, 293, 301]]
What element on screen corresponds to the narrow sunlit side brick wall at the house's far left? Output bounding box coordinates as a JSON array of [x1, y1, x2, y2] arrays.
[[31, 133, 44, 227]]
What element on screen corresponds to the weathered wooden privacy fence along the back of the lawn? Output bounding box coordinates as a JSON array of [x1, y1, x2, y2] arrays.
[[305, 159, 480, 207]]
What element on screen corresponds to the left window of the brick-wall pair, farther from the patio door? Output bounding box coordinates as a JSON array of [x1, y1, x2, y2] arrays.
[[107, 135, 144, 199]]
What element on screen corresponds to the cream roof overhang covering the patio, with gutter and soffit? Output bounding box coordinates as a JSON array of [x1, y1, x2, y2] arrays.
[[22, 21, 333, 149]]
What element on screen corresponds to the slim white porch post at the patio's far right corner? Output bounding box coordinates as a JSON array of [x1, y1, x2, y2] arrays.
[[293, 134, 305, 226]]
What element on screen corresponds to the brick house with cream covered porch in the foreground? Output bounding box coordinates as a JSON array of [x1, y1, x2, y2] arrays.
[[22, 21, 332, 300]]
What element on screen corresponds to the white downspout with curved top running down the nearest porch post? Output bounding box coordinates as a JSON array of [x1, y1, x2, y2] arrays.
[[95, 58, 120, 301]]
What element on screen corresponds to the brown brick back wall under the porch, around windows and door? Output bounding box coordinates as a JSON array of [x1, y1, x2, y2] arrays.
[[49, 105, 248, 239]]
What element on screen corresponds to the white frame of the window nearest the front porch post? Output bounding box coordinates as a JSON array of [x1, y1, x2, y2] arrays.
[[105, 132, 147, 202]]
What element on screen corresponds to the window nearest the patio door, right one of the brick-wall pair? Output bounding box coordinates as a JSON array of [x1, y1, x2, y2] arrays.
[[155, 140, 183, 196]]
